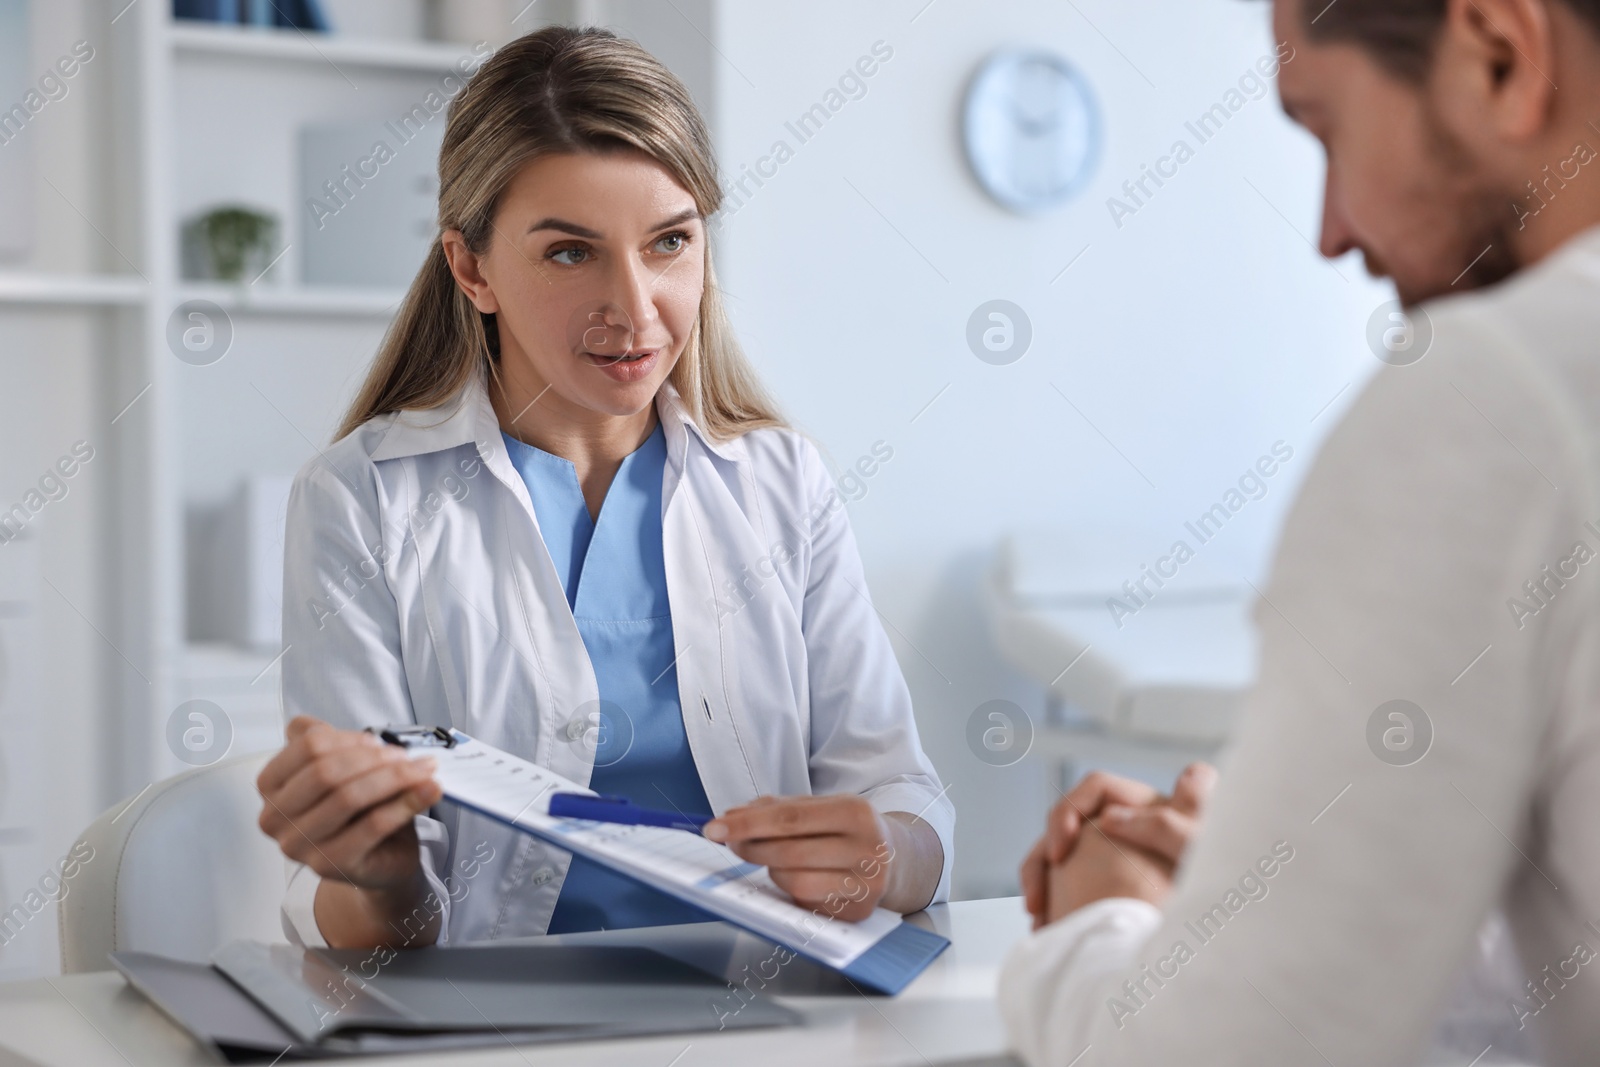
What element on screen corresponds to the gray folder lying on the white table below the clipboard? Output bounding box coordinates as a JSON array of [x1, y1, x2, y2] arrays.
[[110, 941, 800, 1062]]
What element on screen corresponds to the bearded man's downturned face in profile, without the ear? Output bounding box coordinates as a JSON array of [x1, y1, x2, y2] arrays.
[[1274, 0, 1515, 304]]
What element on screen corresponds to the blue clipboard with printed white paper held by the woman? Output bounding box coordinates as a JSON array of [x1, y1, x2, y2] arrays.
[[378, 726, 950, 997]]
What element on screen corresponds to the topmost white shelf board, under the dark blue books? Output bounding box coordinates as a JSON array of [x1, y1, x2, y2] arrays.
[[168, 21, 472, 74]]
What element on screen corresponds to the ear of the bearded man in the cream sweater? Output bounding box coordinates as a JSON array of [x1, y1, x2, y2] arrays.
[[1430, 0, 1566, 149]]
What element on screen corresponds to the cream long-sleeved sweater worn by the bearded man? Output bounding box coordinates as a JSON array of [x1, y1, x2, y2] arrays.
[[1000, 230, 1600, 1067]]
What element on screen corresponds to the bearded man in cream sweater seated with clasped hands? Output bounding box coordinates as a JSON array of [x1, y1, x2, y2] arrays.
[[1000, 0, 1600, 1067]]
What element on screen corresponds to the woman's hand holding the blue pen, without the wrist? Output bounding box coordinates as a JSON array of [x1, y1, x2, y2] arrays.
[[704, 795, 898, 921]]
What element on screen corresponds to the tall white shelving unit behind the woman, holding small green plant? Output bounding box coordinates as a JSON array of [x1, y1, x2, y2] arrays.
[[89, 2, 518, 819]]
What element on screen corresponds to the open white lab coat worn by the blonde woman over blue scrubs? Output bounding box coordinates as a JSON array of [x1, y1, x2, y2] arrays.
[[283, 371, 955, 945]]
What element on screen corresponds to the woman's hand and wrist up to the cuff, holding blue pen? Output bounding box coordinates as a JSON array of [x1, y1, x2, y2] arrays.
[[704, 795, 944, 921]]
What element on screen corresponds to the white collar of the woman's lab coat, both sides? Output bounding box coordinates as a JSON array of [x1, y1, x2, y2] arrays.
[[370, 373, 749, 462]]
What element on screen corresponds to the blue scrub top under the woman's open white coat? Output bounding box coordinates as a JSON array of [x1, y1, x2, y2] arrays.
[[502, 422, 715, 934]]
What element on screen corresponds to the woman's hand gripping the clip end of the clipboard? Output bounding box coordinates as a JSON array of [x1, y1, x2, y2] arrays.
[[256, 715, 443, 893]]
